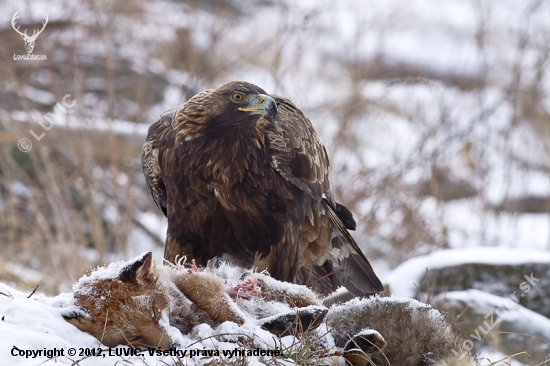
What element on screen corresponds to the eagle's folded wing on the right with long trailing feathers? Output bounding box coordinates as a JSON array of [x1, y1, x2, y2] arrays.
[[267, 95, 384, 295]]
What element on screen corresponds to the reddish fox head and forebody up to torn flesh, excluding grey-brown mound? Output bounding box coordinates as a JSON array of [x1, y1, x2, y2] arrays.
[[64, 252, 326, 349]]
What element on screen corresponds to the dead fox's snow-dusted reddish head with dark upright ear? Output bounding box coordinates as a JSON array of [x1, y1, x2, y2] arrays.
[[64, 252, 171, 349]]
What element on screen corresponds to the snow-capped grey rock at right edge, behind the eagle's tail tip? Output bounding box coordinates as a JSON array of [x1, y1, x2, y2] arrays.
[[385, 247, 550, 317]]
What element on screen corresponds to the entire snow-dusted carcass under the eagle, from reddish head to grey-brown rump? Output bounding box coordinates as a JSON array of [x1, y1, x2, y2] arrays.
[[65, 253, 477, 366]]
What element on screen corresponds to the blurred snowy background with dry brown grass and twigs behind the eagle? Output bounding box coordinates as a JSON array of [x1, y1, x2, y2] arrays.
[[0, 0, 550, 294]]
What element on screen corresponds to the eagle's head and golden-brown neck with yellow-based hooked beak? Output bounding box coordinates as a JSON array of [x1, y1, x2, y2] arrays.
[[175, 81, 277, 183]]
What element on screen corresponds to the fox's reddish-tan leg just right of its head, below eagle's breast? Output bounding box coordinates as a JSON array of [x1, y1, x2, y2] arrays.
[[174, 272, 244, 325]]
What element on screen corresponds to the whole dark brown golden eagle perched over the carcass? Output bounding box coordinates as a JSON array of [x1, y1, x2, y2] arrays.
[[142, 82, 383, 295]]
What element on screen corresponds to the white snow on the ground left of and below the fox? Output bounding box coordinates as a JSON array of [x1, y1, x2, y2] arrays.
[[0, 283, 293, 366]]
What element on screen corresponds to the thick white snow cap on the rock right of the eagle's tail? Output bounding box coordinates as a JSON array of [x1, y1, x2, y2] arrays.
[[384, 247, 550, 297]]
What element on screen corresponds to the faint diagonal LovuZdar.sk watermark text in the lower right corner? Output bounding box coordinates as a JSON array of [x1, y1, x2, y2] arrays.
[[452, 272, 540, 360]]
